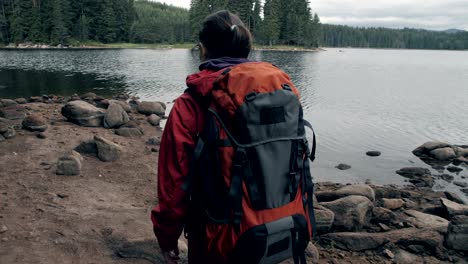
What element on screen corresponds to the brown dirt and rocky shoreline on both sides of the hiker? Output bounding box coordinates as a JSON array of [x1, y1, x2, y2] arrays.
[[0, 93, 468, 263]]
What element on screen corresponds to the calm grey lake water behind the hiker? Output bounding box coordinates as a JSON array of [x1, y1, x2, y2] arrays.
[[0, 49, 468, 192]]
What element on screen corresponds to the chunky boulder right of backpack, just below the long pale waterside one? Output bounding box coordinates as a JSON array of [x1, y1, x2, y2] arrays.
[[321, 195, 373, 231]]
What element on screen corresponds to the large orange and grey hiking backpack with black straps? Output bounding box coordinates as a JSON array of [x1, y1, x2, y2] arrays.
[[183, 62, 315, 264]]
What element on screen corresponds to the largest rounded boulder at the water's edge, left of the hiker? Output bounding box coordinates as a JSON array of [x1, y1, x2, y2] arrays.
[[62, 100, 105, 127]]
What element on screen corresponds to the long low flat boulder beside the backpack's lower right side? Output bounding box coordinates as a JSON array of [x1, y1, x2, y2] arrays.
[[320, 232, 390, 251]]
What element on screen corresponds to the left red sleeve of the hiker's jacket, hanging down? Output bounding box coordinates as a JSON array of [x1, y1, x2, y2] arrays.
[[151, 94, 199, 251]]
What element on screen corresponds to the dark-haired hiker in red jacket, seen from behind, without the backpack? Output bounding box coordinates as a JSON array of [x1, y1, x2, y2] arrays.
[[151, 11, 252, 263]]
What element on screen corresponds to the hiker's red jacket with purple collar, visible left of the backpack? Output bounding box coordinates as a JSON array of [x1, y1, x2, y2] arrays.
[[151, 58, 248, 250]]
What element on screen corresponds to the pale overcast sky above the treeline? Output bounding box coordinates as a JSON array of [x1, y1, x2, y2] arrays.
[[156, 0, 468, 30]]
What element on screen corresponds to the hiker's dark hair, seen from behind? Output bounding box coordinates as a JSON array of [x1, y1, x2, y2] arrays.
[[199, 10, 252, 59]]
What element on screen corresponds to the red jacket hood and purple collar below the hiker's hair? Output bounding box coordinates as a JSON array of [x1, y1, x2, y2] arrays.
[[186, 57, 250, 101]]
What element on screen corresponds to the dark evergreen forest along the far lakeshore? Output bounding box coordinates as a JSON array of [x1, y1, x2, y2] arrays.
[[0, 0, 468, 50]]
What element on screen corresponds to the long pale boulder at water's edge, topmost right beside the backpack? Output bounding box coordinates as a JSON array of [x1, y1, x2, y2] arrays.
[[315, 184, 375, 202]]
